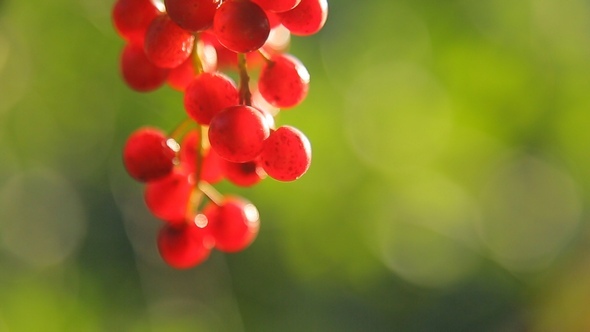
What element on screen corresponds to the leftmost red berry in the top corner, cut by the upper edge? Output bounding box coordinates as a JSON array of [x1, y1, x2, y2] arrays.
[[112, 0, 161, 45]]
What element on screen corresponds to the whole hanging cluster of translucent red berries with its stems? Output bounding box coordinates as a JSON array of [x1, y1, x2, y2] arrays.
[[112, 0, 328, 268]]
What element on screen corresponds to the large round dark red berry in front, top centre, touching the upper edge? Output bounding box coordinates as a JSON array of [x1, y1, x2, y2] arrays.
[[213, 0, 270, 53]]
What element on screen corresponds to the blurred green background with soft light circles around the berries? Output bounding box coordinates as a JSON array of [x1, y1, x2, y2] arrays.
[[0, 0, 590, 332]]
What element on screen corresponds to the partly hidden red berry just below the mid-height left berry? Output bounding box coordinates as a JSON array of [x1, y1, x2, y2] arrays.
[[144, 168, 195, 222]]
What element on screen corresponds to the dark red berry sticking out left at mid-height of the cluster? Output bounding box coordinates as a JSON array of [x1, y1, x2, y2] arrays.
[[123, 127, 178, 182]]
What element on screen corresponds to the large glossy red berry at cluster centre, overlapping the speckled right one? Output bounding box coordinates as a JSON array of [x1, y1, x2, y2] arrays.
[[208, 105, 270, 163]]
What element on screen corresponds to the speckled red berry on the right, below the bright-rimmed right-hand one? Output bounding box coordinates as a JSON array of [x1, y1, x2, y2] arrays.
[[260, 126, 311, 181]]
